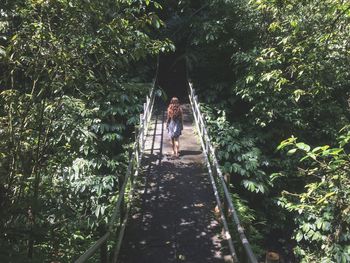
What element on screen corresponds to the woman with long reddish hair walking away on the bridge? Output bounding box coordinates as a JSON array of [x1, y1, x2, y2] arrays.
[[166, 97, 183, 157]]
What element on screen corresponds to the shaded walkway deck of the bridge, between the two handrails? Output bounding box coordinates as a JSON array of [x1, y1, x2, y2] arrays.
[[118, 105, 230, 263]]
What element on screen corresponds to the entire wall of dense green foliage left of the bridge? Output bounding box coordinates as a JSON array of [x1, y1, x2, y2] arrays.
[[0, 0, 173, 262]]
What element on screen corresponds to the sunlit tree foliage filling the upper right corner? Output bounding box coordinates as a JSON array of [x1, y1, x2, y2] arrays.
[[234, 0, 350, 140]]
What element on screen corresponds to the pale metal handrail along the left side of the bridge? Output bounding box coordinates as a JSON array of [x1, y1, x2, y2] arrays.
[[75, 58, 159, 263]]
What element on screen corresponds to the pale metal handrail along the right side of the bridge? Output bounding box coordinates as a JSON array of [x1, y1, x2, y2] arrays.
[[188, 82, 258, 263]]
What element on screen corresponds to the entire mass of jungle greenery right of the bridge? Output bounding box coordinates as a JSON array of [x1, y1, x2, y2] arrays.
[[169, 0, 350, 263]]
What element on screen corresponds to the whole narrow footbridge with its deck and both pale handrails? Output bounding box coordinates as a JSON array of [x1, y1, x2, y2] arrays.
[[75, 82, 258, 263]]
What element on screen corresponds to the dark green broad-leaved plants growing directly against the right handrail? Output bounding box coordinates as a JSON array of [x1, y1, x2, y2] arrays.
[[197, 102, 269, 260]]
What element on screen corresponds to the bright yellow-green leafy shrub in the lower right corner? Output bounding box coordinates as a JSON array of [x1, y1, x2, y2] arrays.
[[279, 126, 350, 263]]
